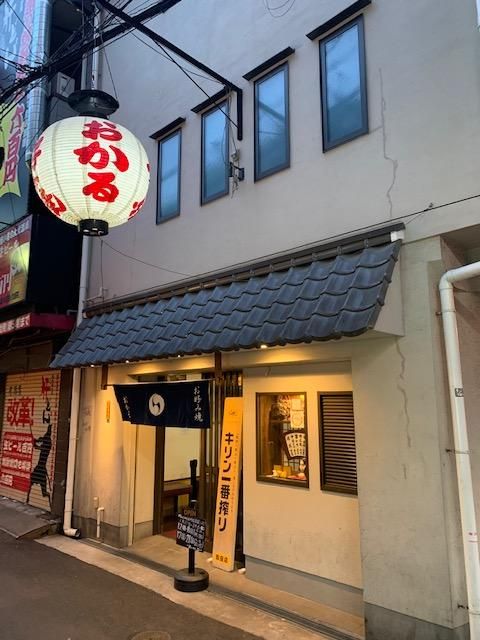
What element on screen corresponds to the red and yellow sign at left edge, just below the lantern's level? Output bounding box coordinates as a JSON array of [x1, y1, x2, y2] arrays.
[[0, 216, 32, 309]]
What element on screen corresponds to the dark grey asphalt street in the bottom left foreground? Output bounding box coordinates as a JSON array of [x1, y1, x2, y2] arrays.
[[0, 532, 258, 640]]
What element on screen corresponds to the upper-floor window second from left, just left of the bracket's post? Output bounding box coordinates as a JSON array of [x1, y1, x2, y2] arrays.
[[202, 102, 229, 204]]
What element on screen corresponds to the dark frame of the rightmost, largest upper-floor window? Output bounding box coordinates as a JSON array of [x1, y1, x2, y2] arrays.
[[319, 14, 369, 153]]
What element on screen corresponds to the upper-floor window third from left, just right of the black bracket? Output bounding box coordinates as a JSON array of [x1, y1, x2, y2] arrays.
[[255, 64, 290, 180]]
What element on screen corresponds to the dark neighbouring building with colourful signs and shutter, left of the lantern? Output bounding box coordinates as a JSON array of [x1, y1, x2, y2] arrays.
[[0, 0, 83, 515]]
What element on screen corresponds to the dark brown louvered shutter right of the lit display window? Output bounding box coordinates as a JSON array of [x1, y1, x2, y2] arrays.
[[319, 392, 357, 494]]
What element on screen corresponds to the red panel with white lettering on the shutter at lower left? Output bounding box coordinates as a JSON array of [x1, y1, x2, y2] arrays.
[[0, 431, 34, 493]]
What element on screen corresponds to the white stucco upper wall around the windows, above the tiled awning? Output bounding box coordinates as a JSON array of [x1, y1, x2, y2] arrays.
[[89, 0, 480, 298]]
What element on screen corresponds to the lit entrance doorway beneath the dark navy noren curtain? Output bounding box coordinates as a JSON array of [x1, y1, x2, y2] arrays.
[[130, 371, 243, 562]]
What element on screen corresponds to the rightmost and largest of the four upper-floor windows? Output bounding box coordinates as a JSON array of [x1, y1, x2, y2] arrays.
[[320, 16, 368, 151]]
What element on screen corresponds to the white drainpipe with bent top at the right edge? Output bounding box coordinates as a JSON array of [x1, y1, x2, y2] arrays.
[[439, 262, 480, 640]]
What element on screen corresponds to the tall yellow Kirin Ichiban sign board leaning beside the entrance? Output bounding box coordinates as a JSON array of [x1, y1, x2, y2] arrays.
[[212, 398, 243, 571]]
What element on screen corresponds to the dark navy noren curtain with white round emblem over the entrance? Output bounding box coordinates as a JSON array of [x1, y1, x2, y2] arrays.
[[113, 380, 210, 429]]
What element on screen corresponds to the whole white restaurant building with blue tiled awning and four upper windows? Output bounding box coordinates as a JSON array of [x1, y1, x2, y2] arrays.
[[54, 0, 480, 640]]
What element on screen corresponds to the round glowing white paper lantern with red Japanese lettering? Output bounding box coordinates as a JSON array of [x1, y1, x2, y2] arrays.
[[32, 116, 150, 235]]
